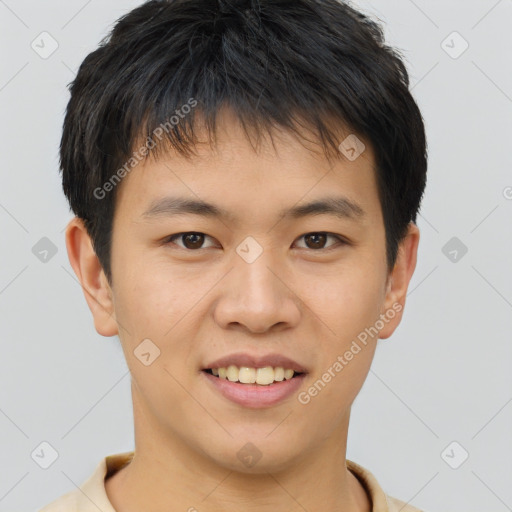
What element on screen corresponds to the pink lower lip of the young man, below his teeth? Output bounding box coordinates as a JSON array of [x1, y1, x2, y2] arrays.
[[201, 371, 306, 409]]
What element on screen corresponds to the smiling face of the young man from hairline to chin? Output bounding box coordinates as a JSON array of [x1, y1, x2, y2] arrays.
[[68, 107, 417, 472]]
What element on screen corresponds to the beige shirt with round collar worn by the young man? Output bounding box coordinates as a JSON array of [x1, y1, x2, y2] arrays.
[[39, 451, 422, 512]]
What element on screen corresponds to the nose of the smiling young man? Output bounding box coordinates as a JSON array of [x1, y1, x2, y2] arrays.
[[214, 251, 301, 334]]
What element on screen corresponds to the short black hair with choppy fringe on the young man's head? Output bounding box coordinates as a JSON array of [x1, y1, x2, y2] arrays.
[[60, 0, 427, 283]]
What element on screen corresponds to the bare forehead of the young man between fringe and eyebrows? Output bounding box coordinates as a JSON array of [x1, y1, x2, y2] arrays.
[[116, 111, 376, 224]]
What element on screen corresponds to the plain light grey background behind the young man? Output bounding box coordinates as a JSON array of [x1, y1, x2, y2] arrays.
[[0, 0, 512, 512]]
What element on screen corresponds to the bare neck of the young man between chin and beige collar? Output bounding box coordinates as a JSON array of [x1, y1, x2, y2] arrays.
[[105, 382, 371, 512]]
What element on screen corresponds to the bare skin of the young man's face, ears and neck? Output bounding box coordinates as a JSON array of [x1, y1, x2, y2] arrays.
[[66, 106, 419, 512]]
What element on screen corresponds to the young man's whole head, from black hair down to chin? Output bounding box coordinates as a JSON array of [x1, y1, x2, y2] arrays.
[[60, 0, 427, 471]]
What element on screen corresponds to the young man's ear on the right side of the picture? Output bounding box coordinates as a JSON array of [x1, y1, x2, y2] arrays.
[[379, 222, 420, 339]]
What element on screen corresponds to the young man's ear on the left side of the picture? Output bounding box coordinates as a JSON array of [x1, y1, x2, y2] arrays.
[[66, 217, 118, 337]]
